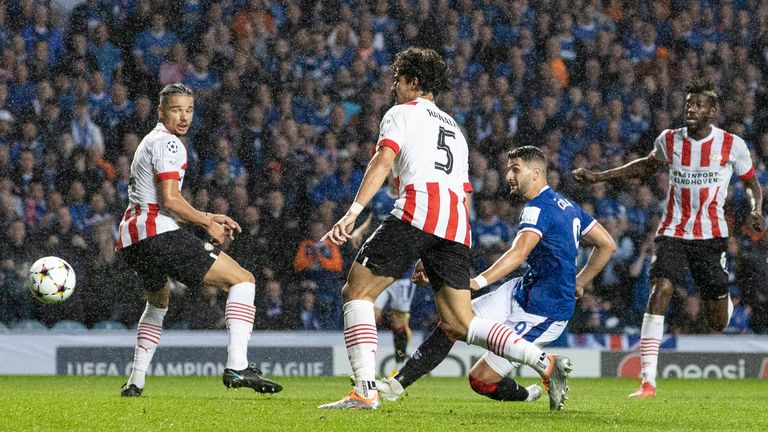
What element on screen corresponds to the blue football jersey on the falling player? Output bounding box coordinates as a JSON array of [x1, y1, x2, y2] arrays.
[[514, 186, 597, 321]]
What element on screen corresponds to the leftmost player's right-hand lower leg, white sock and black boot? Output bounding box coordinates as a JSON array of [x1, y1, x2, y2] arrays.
[[222, 282, 283, 393]]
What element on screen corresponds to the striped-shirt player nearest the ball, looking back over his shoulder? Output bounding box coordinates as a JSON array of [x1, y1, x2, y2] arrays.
[[117, 84, 282, 397]]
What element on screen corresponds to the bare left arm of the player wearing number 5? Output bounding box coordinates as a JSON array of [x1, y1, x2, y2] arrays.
[[323, 146, 397, 245]]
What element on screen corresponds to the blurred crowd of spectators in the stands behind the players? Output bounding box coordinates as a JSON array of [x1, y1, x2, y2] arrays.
[[0, 0, 768, 333]]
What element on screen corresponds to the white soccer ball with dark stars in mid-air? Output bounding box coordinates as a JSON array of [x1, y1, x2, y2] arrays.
[[27, 257, 75, 304]]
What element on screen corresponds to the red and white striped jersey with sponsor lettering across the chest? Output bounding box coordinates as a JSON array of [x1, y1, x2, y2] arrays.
[[651, 126, 755, 240]]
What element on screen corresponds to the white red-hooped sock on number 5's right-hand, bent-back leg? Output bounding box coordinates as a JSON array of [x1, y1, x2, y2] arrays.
[[467, 317, 550, 376]]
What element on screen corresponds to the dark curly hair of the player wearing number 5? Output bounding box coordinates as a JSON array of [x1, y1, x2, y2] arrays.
[[392, 47, 450, 96]]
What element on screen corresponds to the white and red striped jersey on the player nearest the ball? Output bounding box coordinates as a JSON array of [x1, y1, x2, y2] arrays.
[[117, 123, 187, 249]]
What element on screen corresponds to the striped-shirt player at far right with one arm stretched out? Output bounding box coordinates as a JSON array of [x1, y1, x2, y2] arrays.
[[573, 79, 764, 397]]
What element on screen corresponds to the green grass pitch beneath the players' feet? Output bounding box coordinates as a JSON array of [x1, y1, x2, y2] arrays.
[[0, 377, 768, 432]]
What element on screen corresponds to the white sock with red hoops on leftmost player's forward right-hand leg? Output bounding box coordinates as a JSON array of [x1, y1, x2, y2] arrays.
[[224, 282, 256, 370]]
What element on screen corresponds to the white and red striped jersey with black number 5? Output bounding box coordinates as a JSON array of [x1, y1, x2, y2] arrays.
[[376, 98, 472, 246]]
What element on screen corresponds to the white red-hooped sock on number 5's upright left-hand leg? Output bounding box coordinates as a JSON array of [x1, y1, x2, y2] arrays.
[[344, 300, 379, 398]]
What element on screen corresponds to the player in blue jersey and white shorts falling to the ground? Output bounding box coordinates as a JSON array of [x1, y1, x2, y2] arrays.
[[377, 146, 616, 401]]
